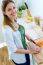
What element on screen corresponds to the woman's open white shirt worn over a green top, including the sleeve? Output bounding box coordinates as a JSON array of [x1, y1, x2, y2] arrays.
[[4, 26, 26, 64]]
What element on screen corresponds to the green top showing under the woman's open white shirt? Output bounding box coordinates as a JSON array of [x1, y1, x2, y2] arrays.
[[18, 25, 27, 49]]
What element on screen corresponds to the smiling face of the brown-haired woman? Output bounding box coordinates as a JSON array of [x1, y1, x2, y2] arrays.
[[5, 2, 17, 20]]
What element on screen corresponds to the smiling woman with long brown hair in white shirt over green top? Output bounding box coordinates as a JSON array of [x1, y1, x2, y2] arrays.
[[2, 0, 39, 65]]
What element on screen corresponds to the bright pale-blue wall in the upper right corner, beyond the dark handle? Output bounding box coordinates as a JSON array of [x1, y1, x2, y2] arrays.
[[27, 0, 43, 18]]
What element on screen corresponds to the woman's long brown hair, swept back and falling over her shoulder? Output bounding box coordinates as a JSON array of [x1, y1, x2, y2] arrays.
[[2, 0, 15, 27]]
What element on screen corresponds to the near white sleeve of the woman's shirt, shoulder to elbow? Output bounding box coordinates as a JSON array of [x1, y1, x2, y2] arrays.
[[5, 28, 17, 52]]
